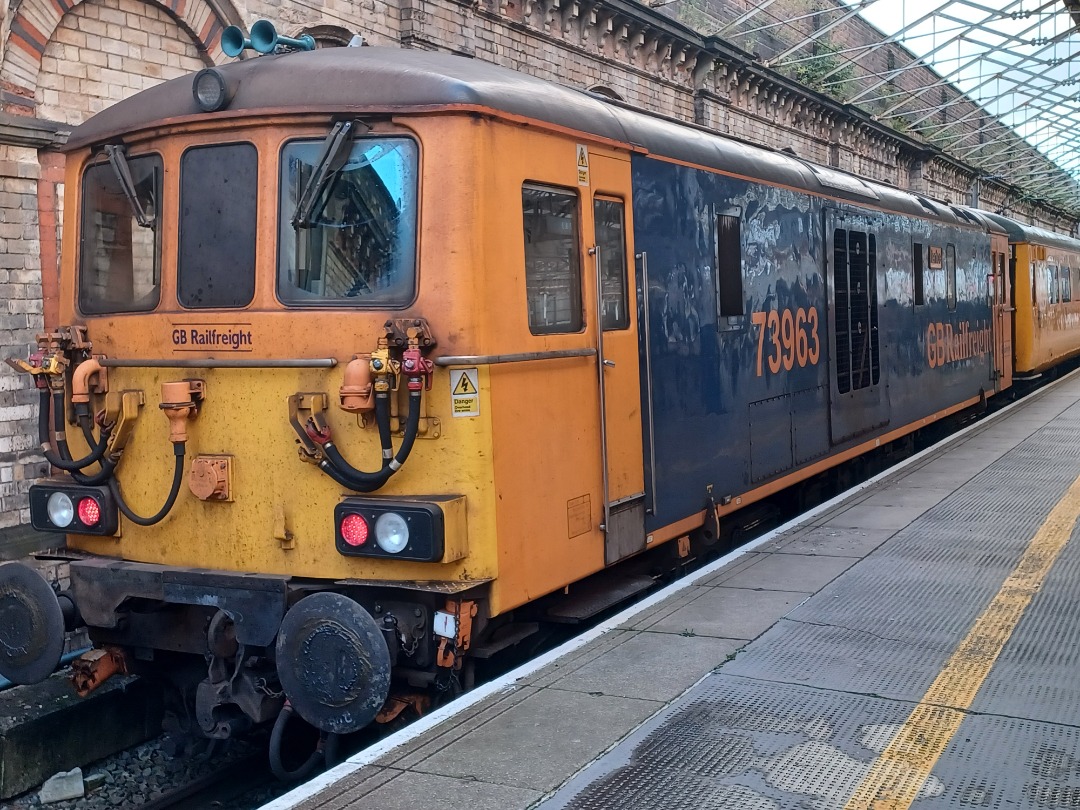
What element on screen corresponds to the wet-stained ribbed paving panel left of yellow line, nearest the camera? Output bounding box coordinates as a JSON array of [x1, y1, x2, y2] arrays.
[[541, 674, 910, 810]]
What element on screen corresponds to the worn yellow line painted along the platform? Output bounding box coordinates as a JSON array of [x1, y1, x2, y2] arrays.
[[845, 477, 1080, 810]]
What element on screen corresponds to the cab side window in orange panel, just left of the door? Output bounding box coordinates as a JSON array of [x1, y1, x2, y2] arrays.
[[522, 186, 584, 335]]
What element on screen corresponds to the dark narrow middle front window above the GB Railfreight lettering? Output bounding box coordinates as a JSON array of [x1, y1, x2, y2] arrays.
[[176, 144, 259, 309]]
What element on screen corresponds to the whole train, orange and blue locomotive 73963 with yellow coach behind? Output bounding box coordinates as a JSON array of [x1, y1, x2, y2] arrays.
[[0, 27, 1080, 773]]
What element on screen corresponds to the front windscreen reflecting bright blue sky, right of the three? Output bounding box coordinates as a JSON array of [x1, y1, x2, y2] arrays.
[[278, 136, 419, 307]]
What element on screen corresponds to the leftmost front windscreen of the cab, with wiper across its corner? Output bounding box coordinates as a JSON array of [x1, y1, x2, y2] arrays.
[[79, 154, 162, 315]]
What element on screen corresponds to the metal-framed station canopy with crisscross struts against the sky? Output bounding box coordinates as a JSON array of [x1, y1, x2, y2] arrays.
[[650, 0, 1080, 218]]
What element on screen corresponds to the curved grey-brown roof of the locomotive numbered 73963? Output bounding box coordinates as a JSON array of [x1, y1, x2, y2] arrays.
[[66, 48, 984, 227]]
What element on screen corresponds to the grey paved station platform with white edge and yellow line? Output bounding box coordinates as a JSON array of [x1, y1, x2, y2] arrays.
[[267, 374, 1080, 810]]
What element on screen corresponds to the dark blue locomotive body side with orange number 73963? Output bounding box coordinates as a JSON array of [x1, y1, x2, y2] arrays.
[[633, 157, 994, 530]]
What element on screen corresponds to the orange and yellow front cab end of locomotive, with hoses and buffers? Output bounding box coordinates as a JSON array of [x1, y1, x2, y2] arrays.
[[0, 31, 646, 756]]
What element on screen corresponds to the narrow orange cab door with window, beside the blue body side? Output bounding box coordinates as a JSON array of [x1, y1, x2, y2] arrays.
[[578, 145, 645, 565]]
